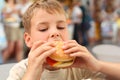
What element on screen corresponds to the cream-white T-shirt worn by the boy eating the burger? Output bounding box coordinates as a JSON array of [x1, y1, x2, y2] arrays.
[[7, 59, 105, 80]]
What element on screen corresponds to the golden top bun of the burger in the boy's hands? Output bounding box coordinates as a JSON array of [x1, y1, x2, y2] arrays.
[[49, 41, 73, 61]]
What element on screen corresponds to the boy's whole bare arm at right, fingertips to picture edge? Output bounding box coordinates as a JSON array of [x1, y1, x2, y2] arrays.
[[63, 40, 120, 79]]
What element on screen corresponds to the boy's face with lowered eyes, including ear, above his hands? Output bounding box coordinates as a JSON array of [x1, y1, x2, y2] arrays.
[[25, 9, 68, 47]]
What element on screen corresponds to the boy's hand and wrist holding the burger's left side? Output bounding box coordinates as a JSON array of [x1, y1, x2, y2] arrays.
[[24, 41, 56, 80]]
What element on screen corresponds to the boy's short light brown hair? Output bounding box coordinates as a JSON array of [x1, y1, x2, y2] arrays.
[[22, 0, 65, 33]]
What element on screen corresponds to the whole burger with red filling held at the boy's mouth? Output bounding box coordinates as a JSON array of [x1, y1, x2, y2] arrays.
[[46, 41, 74, 68]]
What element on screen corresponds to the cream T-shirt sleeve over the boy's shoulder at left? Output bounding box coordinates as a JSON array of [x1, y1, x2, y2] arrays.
[[7, 59, 28, 80]]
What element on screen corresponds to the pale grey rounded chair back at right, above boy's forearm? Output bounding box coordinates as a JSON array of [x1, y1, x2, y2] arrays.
[[92, 44, 120, 62]]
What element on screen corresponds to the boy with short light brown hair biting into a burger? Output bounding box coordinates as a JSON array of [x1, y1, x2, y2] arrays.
[[7, 0, 104, 80]]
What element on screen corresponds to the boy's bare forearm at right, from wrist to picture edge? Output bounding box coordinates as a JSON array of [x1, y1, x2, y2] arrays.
[[100, 61, 120, 79]]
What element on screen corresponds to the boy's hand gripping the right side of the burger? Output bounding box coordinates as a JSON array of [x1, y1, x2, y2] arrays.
[[63, 40, 99, 71]]
